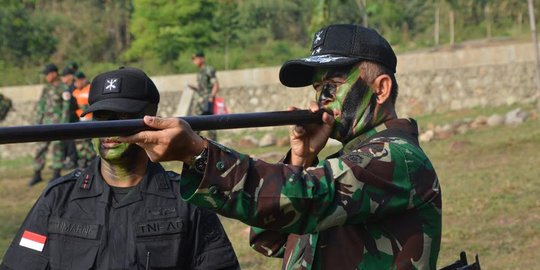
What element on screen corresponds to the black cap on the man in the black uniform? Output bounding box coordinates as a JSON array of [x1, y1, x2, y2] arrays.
[[81, 67, 159, 116]]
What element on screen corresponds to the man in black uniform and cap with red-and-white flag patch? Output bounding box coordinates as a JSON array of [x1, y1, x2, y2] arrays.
[[0, 68, 239, 270]]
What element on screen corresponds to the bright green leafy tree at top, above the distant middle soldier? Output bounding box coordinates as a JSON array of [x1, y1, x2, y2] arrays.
[[125, 0, 215, 63]]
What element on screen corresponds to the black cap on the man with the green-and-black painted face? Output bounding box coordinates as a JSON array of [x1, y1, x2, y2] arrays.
[[279, 24, 397, 87]]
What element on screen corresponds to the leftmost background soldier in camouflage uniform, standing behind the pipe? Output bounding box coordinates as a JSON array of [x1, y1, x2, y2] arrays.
[[28, 64, 71, 186]]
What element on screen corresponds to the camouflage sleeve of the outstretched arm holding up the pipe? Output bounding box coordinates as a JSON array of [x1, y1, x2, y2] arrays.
[[181, 142, 438, 234]]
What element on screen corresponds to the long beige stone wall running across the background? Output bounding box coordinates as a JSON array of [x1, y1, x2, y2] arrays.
[[0, 40, 537, 158]]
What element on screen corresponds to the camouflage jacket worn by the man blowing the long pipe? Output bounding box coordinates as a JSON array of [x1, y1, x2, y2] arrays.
[[181, 119, 442, 269]]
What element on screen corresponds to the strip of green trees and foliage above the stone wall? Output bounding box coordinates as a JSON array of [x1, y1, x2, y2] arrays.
[[0, 0, 540, 85]]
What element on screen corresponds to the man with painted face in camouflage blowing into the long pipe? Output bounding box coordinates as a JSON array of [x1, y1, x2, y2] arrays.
[[122, 25, 442, 270]]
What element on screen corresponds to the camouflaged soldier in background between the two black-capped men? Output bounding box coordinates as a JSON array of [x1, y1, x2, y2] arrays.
[[189, 51, 219, 141]]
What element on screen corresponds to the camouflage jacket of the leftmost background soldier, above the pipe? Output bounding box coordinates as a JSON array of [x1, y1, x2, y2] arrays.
[[34, 81, 71, 124]]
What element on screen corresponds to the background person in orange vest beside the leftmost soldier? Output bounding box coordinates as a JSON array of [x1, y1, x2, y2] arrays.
[[73, 71, 96, 169]]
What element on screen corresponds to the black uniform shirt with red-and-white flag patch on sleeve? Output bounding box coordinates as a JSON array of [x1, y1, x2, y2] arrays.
[[0, 158, 238, 270]]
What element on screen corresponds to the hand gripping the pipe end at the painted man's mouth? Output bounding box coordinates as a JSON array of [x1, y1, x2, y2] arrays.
[[289, 103, 334, 168]]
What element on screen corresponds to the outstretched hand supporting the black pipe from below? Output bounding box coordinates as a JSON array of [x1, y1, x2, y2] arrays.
[[119, 116, 207, 162]]
